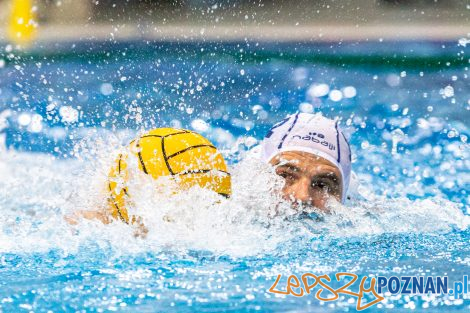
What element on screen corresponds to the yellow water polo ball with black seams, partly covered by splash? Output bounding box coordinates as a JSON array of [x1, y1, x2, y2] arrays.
[[108, 128, 231, 223]]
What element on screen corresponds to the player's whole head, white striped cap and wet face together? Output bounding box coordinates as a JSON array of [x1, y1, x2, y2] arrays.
[[261, 113, 351, 209]]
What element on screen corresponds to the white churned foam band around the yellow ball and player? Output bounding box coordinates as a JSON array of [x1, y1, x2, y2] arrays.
[[0, 140, 470, 257]]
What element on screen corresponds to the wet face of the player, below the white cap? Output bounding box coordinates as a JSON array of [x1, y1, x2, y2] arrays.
[[270, 151, 342, 211]]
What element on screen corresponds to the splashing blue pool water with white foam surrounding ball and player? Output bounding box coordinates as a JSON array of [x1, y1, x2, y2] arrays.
[[0, 42, 470, 312]]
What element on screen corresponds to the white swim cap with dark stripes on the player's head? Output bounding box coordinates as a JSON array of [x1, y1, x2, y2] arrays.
[[261, 113, 351, 203]]
